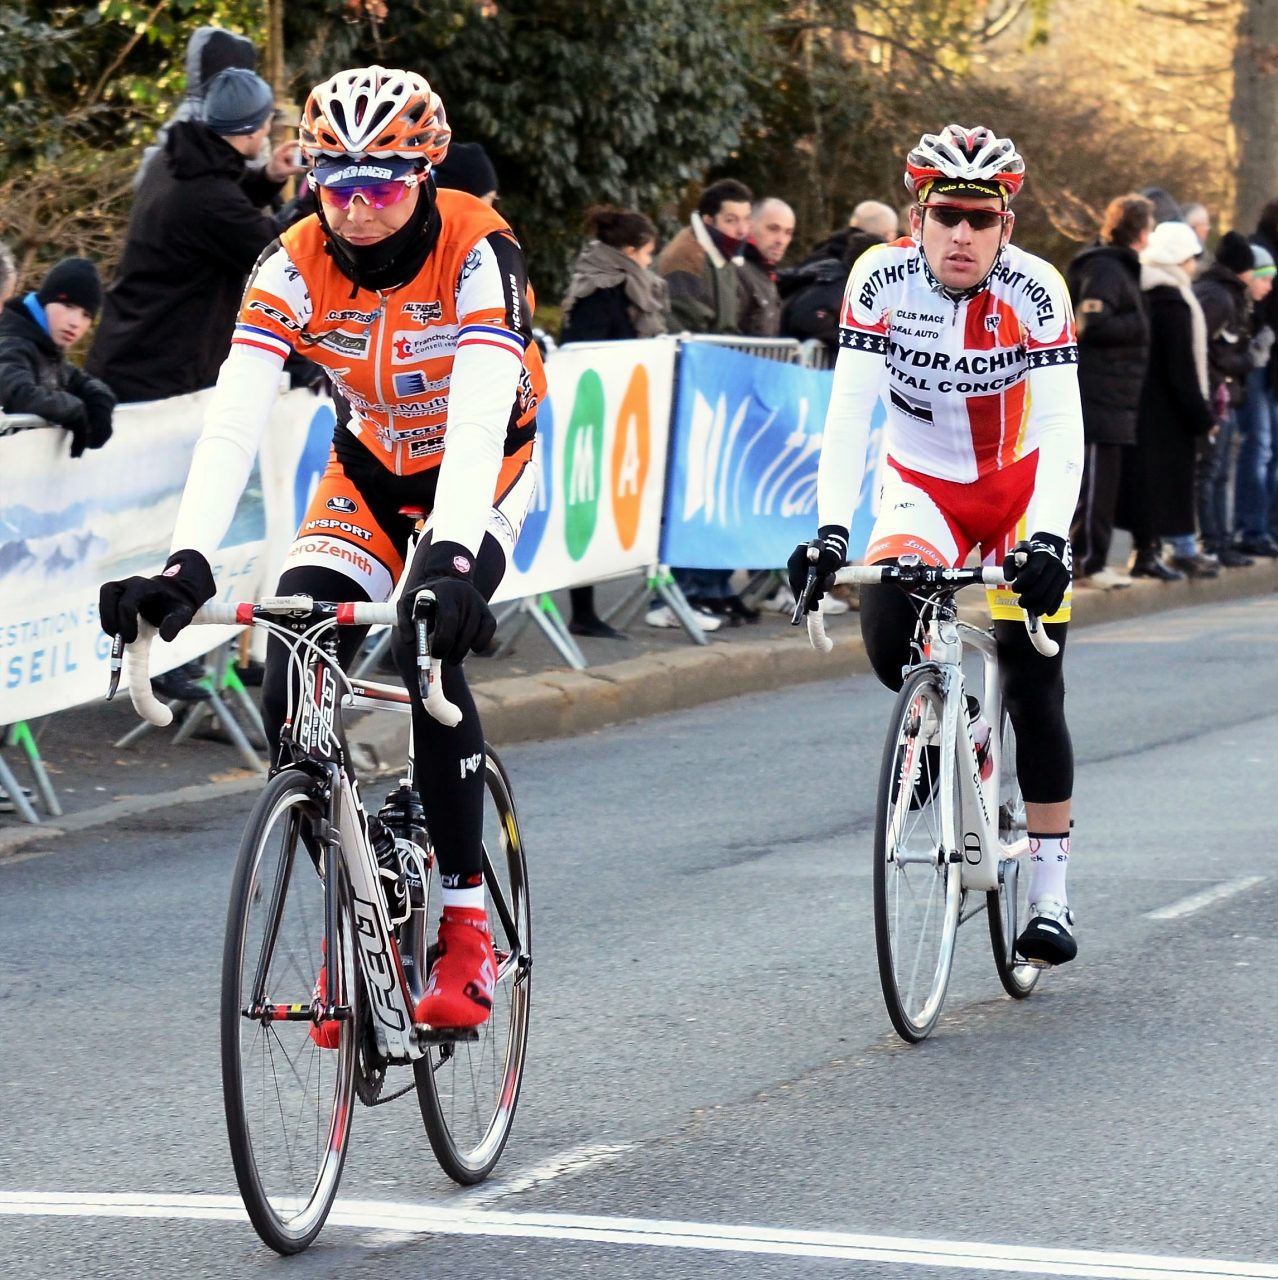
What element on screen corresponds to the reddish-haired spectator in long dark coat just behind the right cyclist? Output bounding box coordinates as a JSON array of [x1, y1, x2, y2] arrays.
[[1065, 195, 1154, 589]]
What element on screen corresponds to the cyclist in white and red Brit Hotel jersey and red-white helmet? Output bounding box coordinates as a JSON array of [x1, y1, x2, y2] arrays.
[[790, 124, 1082, 964]]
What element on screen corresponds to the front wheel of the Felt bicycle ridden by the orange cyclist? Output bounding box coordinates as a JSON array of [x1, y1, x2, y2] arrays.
[[222, 769, 360, 1253]]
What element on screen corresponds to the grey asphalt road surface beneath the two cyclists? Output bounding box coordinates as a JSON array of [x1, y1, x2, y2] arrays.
[[0, 596, 1278, 1280]]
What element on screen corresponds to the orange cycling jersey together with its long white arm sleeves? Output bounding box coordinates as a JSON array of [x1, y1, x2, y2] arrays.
[[173, 191, 546, 556]]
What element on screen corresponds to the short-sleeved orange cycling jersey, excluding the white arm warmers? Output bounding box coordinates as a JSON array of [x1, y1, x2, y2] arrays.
[[232, 191, 546, 475]]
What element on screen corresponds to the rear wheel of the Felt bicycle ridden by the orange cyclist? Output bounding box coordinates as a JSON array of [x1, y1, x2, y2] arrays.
[[414, 749, 533, 1185]]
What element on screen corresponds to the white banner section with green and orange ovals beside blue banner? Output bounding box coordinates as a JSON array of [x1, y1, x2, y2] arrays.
[[496, 338, 677, 600]]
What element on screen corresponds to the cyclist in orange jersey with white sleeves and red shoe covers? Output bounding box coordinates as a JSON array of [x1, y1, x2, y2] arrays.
[[101, 67, 546, 1029]]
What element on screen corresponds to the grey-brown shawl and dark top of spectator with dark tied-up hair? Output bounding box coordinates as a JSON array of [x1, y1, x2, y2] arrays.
[[560, 241, 670, 346]]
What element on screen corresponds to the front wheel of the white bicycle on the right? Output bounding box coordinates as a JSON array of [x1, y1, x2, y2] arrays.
[[875, 668, 962, 1043]]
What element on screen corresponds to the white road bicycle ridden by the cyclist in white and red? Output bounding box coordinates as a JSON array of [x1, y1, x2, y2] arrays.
[[794, 556, 1059, 1043]]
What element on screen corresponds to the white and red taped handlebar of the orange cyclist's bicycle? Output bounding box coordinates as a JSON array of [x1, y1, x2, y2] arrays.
[[106, 590, 461, 728]]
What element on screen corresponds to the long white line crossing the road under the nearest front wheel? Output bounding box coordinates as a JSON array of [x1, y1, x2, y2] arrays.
[[0, 1192, 1278, 1280]]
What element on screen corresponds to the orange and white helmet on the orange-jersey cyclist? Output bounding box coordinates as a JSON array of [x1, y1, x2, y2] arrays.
[[300, 67, 452, 168]]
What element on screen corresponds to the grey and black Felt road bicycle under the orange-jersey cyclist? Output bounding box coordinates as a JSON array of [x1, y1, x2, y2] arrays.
[[111, 591, 533, 1253]]
